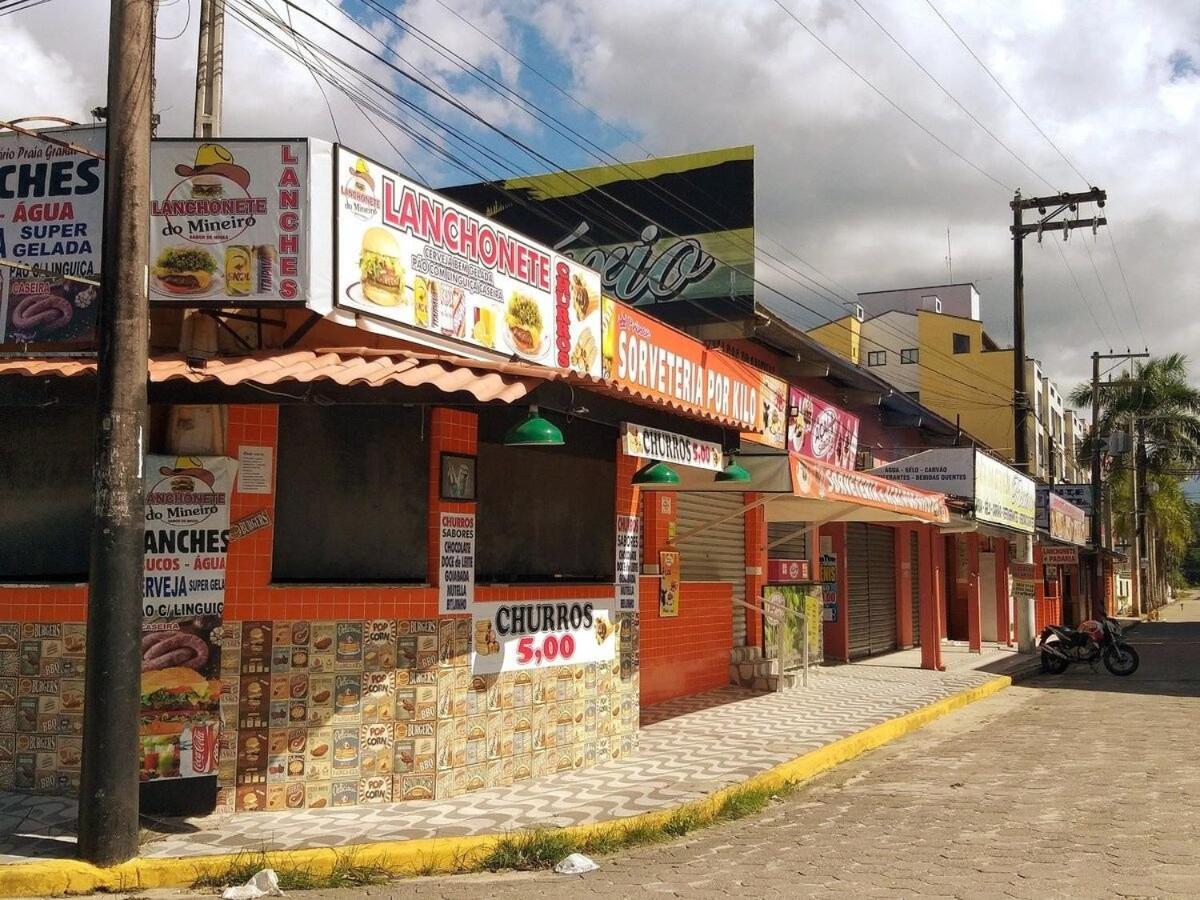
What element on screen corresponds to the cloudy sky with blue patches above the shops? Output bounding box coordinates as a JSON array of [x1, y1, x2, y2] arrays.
[[0, 0, 1200, 398]]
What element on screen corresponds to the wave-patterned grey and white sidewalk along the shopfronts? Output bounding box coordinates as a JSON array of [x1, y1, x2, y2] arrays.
[[0, 666, 1009, 894]]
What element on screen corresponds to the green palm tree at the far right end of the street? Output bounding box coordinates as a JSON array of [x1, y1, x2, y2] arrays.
[[1069, 353, 1200, 609]]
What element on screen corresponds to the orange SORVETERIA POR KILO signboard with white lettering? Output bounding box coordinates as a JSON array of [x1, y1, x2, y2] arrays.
[[602, 298, 763, 433]]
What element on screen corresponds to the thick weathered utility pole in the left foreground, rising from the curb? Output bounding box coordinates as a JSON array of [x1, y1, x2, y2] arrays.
[[79, 0, 154, 865]]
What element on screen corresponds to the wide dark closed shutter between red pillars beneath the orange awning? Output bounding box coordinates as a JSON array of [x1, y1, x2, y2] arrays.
[[846, 522, 898, 659]]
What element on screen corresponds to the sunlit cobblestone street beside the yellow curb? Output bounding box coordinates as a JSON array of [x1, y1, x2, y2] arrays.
[[223, 601, 1200, 900]]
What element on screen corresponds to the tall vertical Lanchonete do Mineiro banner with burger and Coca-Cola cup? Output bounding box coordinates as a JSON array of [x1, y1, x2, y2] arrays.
[[138, 456, 238, 781]]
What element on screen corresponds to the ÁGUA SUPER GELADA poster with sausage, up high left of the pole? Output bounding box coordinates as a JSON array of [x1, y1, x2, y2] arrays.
[[0, 128, 104, 347]]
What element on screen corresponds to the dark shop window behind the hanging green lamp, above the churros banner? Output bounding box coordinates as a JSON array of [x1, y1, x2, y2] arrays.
[[475, 410, 617, 583]]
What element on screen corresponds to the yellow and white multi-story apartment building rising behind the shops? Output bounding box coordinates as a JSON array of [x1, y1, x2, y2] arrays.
[[810, 283, 1082, 481]]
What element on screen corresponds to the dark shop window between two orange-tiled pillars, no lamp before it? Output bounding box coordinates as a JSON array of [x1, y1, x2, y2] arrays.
[[272, 406, 430, 583]]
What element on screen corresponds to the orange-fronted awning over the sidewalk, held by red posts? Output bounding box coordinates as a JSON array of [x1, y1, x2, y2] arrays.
[[643, 452, 950, 523]]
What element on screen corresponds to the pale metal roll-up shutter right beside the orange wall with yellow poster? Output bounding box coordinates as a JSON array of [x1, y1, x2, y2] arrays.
[[676, 492, 746, 647]]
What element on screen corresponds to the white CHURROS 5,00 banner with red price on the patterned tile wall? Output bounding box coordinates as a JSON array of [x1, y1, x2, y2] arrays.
[[470, 600, 620, 674]]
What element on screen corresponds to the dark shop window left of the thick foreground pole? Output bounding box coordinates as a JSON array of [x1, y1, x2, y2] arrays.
[[0, 407, 96, 583]]
